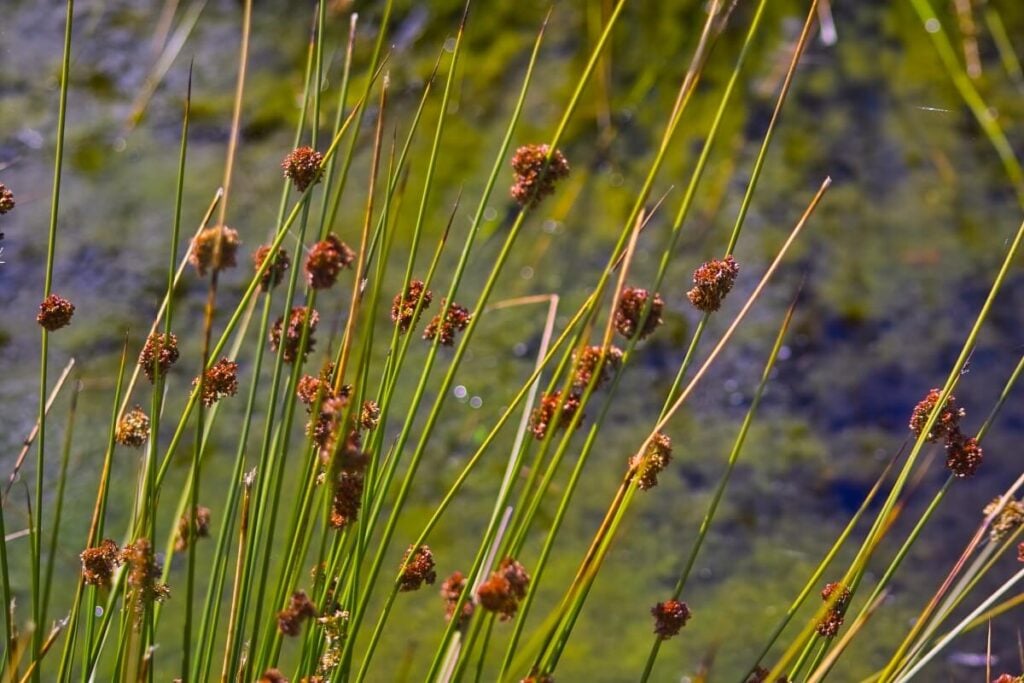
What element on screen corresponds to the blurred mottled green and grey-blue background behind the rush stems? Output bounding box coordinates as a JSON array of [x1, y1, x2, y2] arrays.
[[0, 0, 1024, 681]]
